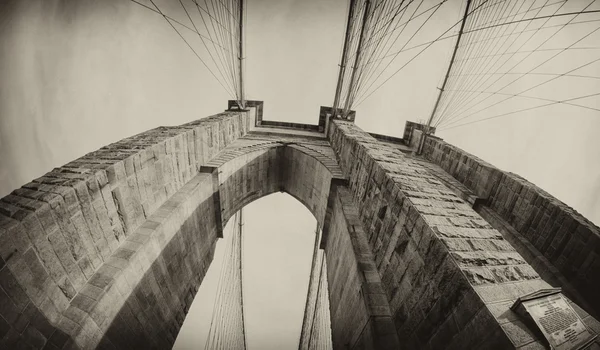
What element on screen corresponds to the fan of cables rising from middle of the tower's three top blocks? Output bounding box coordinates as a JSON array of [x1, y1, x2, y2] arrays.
[[333, 0, 458, 115]]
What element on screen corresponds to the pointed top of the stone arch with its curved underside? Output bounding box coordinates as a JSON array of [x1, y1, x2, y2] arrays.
[[207, 139, 344, 226]]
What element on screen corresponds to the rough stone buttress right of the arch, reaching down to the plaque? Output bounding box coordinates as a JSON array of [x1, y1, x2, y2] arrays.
[[329, 121, 591, 349]]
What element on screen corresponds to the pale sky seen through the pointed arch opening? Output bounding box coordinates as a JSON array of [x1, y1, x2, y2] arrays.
[[174, 193, 317, 350]]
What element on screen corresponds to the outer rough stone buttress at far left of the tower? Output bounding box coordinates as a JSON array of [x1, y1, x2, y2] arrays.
[[0, 110, 254, 348]]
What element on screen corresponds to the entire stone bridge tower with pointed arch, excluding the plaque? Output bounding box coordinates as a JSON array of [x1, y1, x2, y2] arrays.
[[0, 101, 600, 349]]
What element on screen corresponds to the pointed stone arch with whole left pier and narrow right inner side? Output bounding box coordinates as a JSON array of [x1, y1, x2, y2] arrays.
[[0, 105, 404, 349]]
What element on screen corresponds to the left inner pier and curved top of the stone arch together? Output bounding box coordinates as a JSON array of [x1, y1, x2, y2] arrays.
[[59, 120, 346, 349]]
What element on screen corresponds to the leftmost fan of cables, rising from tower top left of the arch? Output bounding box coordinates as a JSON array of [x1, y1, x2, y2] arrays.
[[130, 0, 246, 108]]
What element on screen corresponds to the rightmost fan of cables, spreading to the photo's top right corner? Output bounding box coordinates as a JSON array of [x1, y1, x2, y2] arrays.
[[430, 0, 600, 130]]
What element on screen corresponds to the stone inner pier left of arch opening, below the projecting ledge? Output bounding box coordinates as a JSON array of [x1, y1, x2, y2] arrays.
[[99, 174, 221, 349]]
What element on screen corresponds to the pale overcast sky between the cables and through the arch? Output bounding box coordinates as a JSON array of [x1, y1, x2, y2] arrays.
[[0, 0, 600, 349]]
